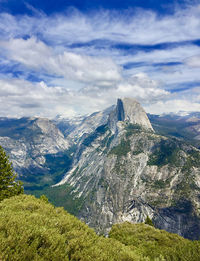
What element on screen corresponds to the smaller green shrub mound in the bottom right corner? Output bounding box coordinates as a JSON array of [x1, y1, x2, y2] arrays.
[[109, 222, 200, 261]]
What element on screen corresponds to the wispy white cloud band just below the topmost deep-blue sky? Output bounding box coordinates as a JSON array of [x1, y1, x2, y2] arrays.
[[0, 3, 200, 45]]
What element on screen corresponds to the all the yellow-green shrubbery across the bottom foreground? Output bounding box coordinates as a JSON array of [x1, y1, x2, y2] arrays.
[[0, 195, 200, 261]]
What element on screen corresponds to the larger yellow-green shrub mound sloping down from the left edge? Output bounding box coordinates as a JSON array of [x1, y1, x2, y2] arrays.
[[0, 195, 144, 261]]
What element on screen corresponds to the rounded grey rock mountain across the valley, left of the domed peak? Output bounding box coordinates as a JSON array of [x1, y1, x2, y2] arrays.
[[0, 118, 69, 187]]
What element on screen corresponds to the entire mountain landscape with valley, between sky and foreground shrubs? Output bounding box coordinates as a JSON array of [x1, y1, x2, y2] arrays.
[[0, 98, 200, 239]]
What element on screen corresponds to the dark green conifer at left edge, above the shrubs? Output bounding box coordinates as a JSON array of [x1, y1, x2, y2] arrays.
[[0, 146, 24, 201]]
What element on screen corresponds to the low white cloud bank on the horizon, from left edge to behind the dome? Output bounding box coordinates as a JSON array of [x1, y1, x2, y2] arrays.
[[0, 74, 168, 117]]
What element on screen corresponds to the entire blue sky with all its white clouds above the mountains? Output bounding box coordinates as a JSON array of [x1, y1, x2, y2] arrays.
[[0, 0, 200, 118]]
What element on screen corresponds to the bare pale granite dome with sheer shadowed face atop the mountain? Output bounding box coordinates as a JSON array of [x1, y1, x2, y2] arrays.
[[109, 98, 153, 131]]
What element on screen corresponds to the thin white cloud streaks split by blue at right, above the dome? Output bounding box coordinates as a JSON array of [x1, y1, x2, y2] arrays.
[[114, 45, 200, 86]]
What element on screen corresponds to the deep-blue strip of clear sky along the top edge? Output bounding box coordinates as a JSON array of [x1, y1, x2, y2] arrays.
[[1, 0, 193, 15]]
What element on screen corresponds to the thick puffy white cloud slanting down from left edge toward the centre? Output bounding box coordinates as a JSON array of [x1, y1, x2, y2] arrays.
[[0, 37, 121, 85]]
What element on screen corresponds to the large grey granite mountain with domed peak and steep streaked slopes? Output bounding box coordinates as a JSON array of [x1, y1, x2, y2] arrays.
[[57, 99, 200, 239]]
